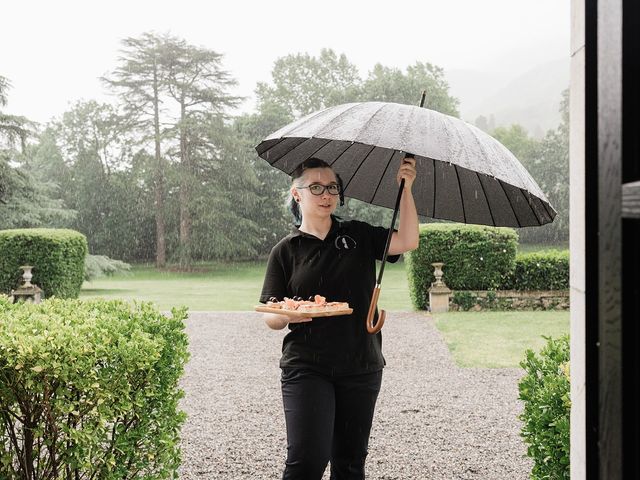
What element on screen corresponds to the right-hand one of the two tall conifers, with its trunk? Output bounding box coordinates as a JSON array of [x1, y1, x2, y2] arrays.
[[163, 37, 239, 269]]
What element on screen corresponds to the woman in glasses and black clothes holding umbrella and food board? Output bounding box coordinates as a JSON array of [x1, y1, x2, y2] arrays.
[[260, 158, 418, 480]]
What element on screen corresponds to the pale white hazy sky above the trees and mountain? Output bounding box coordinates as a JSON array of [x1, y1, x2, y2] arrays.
[[0, 0, 570, 122]]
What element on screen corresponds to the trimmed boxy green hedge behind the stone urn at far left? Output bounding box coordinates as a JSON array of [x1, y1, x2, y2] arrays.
[[0, 228, 88, 298]]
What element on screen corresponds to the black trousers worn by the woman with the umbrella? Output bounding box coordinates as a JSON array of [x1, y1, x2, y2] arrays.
[[282, 368, 382, 480]]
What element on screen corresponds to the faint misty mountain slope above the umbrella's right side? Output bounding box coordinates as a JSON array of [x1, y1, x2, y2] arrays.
[[446, 58, 569, 137]]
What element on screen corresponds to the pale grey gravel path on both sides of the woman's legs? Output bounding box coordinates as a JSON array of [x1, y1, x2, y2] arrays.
[[180, 312, 531, 480]]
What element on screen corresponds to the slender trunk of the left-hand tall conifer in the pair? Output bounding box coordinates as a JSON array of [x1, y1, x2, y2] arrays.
[[153, 58, 167, 268]]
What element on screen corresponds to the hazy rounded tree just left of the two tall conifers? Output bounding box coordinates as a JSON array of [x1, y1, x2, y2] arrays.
[[40, 101, 154, 260]]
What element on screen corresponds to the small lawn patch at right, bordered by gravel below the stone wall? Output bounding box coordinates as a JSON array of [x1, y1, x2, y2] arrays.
[[434, 311, 569, 368]]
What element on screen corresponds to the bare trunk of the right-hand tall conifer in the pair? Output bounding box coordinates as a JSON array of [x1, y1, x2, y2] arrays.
[[180, 98, 192, 270]]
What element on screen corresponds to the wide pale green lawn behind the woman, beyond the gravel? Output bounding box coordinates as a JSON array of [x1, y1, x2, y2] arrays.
[[80, 262, 412, 311]]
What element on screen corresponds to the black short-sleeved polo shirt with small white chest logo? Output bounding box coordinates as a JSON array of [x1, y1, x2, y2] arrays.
[[260, 217, 399, 375]]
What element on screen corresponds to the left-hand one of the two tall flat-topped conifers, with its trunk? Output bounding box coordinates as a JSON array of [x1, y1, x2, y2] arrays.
[[104, 33, 168, 268]]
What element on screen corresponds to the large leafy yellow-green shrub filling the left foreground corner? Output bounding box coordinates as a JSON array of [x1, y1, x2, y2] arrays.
[[0, 297, 188, 480]]
